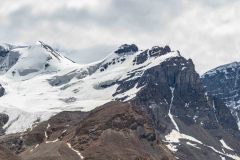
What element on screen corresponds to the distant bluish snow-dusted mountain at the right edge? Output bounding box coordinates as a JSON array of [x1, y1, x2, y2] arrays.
[[201, 62, 240, 129]]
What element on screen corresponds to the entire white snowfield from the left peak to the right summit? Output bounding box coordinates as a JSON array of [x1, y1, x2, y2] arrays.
[[0, 42, 180, 133]]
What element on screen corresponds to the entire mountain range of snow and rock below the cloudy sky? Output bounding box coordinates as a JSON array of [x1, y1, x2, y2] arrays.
[[0, 42, 240, 160]]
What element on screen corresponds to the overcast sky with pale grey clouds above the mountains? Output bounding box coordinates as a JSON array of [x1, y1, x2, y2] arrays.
[[0, 0, 240, 73]]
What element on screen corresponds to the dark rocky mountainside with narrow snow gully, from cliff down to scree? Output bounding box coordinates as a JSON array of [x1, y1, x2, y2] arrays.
[[112, 53, 240, 160]]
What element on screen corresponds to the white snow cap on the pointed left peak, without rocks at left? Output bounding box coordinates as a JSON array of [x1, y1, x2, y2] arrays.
[[6, 43, 75, 80]]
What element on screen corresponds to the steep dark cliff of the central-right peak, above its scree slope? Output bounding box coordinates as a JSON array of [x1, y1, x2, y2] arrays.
[[137, 57, 237, 130]]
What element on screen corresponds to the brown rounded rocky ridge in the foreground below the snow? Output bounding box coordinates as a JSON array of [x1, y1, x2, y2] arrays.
[[0, 102, 175, 160]]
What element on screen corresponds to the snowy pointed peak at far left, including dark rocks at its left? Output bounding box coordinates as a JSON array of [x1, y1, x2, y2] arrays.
[[0, 41, 73, 80]]
